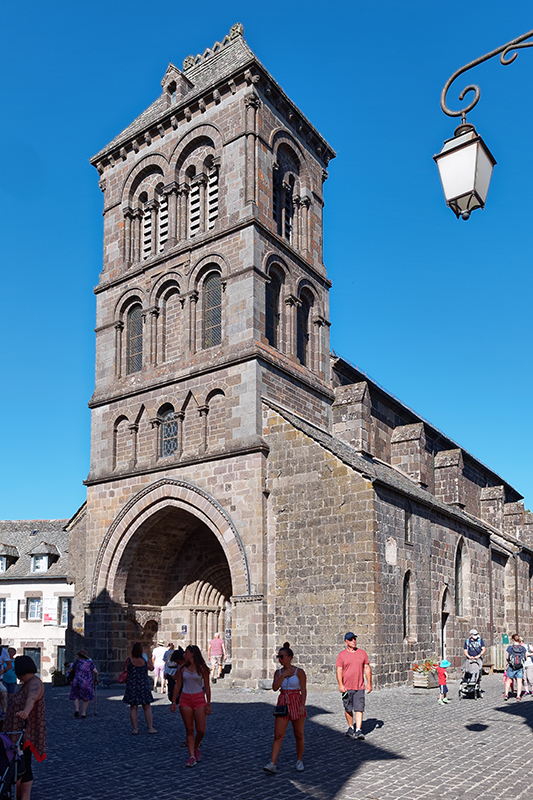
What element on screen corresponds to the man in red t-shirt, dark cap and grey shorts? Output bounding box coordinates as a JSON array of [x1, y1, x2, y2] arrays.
[[335, 631, 372, 739]]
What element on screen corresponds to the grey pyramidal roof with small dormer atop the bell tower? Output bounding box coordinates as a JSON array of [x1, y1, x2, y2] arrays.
[[91, 23, 335, 164]]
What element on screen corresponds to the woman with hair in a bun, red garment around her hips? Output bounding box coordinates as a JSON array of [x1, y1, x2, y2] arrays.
[[263, 642, 307, 775]]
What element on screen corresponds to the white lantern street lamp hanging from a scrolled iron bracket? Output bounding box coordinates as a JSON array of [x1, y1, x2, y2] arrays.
[[433, 31, 533, 219]]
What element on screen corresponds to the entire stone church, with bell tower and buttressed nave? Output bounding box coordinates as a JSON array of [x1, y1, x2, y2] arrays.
[[65, 24, 533, 686]]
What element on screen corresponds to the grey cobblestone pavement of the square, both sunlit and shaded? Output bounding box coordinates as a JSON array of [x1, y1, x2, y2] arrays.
[[32, 675, 533, 800]]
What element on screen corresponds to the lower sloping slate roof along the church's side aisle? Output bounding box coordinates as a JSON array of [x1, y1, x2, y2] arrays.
[[263, 397, 525, 546]]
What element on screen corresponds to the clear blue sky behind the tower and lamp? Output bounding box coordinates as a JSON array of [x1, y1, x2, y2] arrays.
[[0, 0, 533, 519]]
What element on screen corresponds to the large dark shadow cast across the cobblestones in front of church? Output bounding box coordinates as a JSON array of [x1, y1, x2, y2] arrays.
[[37, 688, 402, 800]]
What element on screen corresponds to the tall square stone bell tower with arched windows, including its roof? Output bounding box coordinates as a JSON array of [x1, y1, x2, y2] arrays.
[[80, 24, 334, 681]]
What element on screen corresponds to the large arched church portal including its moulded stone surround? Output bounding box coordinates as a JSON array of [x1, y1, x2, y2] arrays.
[[90, 480, 250, 672]]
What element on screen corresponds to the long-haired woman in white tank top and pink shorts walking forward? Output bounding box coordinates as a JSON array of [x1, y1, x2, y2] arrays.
[[170, 644, 211, 767]]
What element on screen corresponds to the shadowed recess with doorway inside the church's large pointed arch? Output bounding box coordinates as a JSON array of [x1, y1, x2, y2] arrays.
[[114, 507, 232, 658]]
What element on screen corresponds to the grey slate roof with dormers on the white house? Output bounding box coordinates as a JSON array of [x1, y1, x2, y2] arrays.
[[0, 519, 68, 583]]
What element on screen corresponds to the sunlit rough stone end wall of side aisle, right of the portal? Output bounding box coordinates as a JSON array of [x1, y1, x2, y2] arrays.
[[263, 408, 377, 686]]
